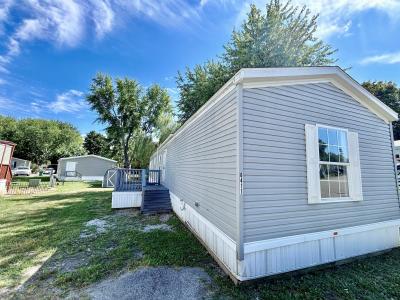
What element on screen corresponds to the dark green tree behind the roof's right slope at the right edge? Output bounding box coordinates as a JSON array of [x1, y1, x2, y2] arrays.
[[362, 81, 400, 140]]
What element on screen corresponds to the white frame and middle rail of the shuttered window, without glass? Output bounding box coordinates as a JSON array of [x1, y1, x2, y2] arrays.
[[316, 124, 352, 203]]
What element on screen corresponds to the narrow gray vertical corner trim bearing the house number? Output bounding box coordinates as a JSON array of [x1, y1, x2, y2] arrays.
[[236, 81, 244, 261]]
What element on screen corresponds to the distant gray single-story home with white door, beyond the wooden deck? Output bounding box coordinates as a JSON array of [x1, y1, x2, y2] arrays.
[[57, 154, 117, 181]]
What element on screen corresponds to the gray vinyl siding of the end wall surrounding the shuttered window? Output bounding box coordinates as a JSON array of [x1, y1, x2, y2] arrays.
[[243, 83, 400, 242]]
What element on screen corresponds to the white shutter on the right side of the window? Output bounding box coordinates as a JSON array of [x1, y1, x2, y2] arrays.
[[348, 132, 363, 201]]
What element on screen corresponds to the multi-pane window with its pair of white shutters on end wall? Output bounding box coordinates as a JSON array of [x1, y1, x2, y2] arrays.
[[305, 124, 362, 203]]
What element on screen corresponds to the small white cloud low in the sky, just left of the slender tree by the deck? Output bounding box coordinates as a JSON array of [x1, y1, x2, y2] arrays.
[[48, 90, 88, 113]]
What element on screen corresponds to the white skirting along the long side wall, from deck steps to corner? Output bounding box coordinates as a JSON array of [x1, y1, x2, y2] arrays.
[[170, 192, 237, 274]]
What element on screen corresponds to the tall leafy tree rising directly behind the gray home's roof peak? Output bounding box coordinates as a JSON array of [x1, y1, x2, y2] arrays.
[[177, 0, 336, 122]]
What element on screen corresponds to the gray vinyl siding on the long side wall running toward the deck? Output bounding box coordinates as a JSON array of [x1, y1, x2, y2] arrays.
[[153, 90, 238, 240]]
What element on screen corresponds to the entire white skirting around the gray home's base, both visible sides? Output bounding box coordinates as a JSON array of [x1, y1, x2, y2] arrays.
[[170, 192, 400, 281]]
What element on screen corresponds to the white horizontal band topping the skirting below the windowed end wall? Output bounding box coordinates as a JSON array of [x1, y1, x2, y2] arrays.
[[244, 219, 400, 254]]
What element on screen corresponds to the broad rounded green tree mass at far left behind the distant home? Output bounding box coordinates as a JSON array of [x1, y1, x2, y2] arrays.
[[0, 116, 84, 164]]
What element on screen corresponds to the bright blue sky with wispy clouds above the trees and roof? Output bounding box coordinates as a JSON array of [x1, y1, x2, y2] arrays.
[[0, 0, 400, 134]]
